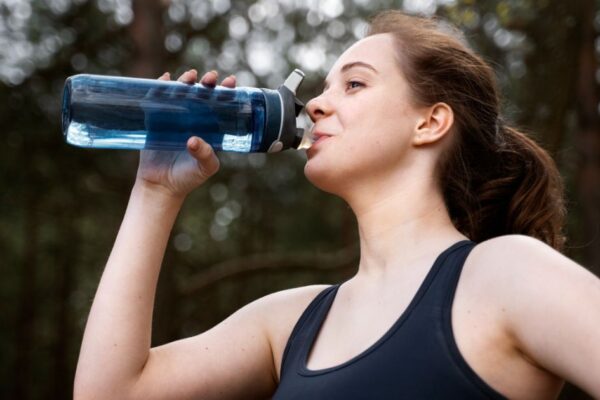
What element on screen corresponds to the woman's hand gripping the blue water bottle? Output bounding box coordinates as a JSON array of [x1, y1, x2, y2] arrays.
[[136, 69, 236, 197]]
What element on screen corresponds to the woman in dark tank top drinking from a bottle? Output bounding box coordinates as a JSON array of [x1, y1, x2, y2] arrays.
[[75, 12, 600, 399]]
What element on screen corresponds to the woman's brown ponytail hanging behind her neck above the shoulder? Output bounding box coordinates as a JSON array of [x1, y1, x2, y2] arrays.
[[438, 123, 565, 250]]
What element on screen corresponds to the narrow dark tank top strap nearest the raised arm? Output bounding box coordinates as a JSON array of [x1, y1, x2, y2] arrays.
[[280, 283, 340, 379]]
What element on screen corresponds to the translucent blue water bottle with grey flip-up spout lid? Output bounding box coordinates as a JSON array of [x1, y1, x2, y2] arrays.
[[62, 69, 310, 152]]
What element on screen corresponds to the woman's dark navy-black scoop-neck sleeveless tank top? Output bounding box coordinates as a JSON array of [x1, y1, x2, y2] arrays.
[[273, 240, 505, 400]]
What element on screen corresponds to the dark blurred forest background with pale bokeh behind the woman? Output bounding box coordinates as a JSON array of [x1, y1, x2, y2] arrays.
[[0, 0, 600, 399]]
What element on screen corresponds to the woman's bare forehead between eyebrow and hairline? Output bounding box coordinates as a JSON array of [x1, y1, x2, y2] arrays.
[[329, 33, 397, 76]]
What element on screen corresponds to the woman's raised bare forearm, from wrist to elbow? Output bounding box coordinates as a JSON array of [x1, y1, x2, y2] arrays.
[[75, 184, 183, 398]]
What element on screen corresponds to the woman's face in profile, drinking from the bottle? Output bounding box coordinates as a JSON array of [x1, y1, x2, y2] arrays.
[[304, 34, 419, 194]]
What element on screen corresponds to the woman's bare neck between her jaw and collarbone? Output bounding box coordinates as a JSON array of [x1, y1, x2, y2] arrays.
[[346, 170, 466, 280]]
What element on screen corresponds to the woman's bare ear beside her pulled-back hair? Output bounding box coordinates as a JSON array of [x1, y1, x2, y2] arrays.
[[413, 103, 454, 146]]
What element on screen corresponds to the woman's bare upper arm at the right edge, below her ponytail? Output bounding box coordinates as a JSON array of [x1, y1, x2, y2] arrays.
[[488, 235, 600, 398]]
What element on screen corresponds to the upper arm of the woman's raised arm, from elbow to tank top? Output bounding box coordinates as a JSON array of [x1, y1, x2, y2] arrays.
[[127, 286, 328, 400]]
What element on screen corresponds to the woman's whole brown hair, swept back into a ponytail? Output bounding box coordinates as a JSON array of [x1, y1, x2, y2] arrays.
[[368, 11, 565, 249]]
